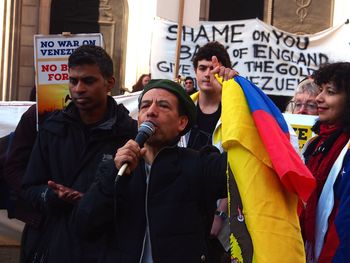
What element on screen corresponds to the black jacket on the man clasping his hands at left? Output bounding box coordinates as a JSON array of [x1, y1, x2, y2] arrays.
[[23, 97, 137, 263]]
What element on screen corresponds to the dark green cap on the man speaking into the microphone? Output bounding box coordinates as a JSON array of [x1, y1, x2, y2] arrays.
[[139, 79, 197, 135]]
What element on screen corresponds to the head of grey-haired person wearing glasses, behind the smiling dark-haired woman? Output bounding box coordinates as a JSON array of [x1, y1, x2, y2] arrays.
[[287, 78, 319, 115]]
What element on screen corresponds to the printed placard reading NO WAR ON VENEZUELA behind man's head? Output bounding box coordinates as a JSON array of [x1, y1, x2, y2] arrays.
[[34, 34, 103, 120]]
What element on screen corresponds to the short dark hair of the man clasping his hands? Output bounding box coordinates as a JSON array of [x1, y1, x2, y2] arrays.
[[68, 45, 113, 79]]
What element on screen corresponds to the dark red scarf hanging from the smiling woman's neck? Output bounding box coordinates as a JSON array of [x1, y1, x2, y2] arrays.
[[301, 124, 349, 256]]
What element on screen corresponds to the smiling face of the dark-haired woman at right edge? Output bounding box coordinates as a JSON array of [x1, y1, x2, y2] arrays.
[[316, 83, 347, 124]]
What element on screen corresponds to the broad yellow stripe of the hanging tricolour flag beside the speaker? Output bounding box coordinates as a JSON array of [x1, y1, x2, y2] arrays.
[[221, 79, 305, 263]]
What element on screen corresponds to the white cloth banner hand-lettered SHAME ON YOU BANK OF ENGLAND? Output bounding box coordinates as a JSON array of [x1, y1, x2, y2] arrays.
[[151, 19, 350, 96]]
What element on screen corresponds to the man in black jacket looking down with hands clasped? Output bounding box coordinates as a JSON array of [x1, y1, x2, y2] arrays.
[[22, 46, 137, 263]]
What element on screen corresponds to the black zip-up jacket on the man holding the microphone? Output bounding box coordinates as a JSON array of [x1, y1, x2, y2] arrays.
[[73, 147, 226, 263]]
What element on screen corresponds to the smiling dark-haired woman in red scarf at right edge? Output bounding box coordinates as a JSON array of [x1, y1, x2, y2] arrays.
[[300, 62, 350, 263]]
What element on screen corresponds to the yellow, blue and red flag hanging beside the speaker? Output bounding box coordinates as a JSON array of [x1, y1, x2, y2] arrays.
[[221, 76, 315, 263]]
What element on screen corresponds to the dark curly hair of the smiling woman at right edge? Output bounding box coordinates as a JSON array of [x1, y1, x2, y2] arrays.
[[312, 62, 350, 133]]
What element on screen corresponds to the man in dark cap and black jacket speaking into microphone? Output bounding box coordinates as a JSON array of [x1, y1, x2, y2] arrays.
[[72, 80, 226, 263]]
